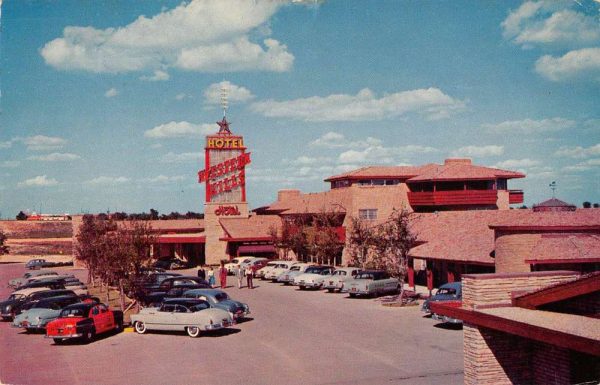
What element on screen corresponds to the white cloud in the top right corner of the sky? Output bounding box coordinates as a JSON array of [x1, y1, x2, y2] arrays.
[[501, 0, 600, 48]]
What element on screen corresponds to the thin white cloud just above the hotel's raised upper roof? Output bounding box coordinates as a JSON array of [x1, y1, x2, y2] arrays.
[[338, 145, 438, 164]]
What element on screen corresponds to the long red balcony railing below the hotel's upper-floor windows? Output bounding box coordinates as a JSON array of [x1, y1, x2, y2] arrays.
[[408, 190, 498, 206]]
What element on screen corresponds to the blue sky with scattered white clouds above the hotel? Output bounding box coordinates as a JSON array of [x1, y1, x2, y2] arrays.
[[0, 0, 600, 217]]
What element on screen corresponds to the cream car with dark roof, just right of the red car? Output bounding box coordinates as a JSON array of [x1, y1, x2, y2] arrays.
[[131, 298, 233, 338]]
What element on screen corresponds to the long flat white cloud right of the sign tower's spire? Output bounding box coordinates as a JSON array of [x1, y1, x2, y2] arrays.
[[251, 88, 466, 122]]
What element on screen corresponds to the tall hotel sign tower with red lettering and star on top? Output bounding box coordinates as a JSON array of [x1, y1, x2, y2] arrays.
[[198, 88, 250, 264]]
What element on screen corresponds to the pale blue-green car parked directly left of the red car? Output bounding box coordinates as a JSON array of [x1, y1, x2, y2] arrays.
[[13, 295, 82, 332]]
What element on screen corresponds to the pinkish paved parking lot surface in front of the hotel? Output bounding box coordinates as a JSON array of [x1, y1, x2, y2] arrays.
[[0, 264, 463, 385]]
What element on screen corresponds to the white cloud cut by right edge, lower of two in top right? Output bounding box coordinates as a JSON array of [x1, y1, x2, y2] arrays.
[[535, 48, 600, 82]]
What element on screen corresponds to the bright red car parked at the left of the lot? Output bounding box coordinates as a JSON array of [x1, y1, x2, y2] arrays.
[[46, 303, 123, 344]]
